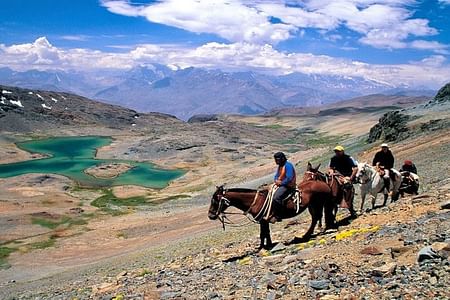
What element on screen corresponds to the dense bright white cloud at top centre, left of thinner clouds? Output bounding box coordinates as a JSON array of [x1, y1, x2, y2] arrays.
[[102, 0, 296, 43]]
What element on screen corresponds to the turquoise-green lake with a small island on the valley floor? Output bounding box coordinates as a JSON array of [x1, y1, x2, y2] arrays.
[[0, 136, 185, 188]]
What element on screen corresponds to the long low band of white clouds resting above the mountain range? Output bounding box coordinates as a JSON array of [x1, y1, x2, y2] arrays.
[[0, 37, 450, 88]]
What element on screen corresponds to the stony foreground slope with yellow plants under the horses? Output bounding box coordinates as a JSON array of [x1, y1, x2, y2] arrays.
[[4, 131, 450, 299]]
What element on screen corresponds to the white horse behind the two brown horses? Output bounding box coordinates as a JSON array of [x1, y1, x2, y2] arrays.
[[356, 163, 401, 211]]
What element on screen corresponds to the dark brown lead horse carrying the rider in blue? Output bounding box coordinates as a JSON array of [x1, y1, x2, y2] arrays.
[[208, 181, 331, 249]]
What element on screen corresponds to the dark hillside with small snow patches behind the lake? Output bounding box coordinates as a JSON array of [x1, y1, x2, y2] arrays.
[[0, 85, 181, 132]]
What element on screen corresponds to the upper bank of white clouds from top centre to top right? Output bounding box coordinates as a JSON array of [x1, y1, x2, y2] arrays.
[[101, 0, 437, 49]]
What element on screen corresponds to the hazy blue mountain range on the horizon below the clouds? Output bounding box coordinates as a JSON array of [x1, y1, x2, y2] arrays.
[[0, 64, 436, 120]]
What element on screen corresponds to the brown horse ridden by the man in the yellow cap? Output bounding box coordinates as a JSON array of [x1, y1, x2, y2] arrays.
[[303, 162, 356, 220]]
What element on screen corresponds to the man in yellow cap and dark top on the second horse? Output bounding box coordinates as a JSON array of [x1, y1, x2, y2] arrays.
[[328, 145, 358, 216]]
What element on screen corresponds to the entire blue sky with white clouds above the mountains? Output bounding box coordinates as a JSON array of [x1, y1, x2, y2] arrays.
[[0, 0, 450, 88]]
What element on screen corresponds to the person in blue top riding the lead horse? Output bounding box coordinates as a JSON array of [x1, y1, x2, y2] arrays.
[[270, 152, 296, 222]]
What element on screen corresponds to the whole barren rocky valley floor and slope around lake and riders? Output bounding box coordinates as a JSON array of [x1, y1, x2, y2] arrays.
[[0, 83, 450, 299]]
